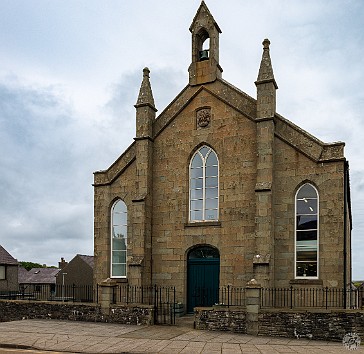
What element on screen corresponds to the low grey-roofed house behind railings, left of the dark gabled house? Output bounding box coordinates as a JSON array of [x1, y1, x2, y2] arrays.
[[19, 267, 59, 300]]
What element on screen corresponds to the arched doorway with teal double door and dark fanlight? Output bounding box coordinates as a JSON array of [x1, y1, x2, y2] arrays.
[[187, 246, 220, 313]]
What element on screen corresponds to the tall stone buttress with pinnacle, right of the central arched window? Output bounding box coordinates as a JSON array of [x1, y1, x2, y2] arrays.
[[253, 39, 278, 286]]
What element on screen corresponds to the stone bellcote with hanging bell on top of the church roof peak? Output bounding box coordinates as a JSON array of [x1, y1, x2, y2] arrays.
[[188, 1, 222, 85]]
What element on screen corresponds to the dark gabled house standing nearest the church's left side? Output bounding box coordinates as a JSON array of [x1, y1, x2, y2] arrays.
[[56, 254, 94, 301]]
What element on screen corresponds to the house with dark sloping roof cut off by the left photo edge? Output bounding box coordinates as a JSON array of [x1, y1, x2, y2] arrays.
[[0, 245, 18, 294]]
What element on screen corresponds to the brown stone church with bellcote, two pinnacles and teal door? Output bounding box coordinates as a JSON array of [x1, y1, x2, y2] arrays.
[[94, 1, 351, 310]]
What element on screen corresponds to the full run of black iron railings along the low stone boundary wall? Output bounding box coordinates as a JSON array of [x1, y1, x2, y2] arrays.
[[0, 284, 364, 310]]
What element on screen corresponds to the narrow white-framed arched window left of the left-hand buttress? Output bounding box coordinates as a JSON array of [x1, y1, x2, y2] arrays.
[[111, 200, 128, 278]]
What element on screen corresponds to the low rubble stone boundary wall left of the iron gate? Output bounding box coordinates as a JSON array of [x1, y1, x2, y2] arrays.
[[0, 300, 154, 325]]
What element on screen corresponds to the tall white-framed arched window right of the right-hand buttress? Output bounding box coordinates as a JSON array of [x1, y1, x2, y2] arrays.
[[295, 183, 319, 278]]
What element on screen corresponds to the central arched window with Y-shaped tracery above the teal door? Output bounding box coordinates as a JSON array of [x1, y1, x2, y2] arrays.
[[189, 145, 219, 222]]
